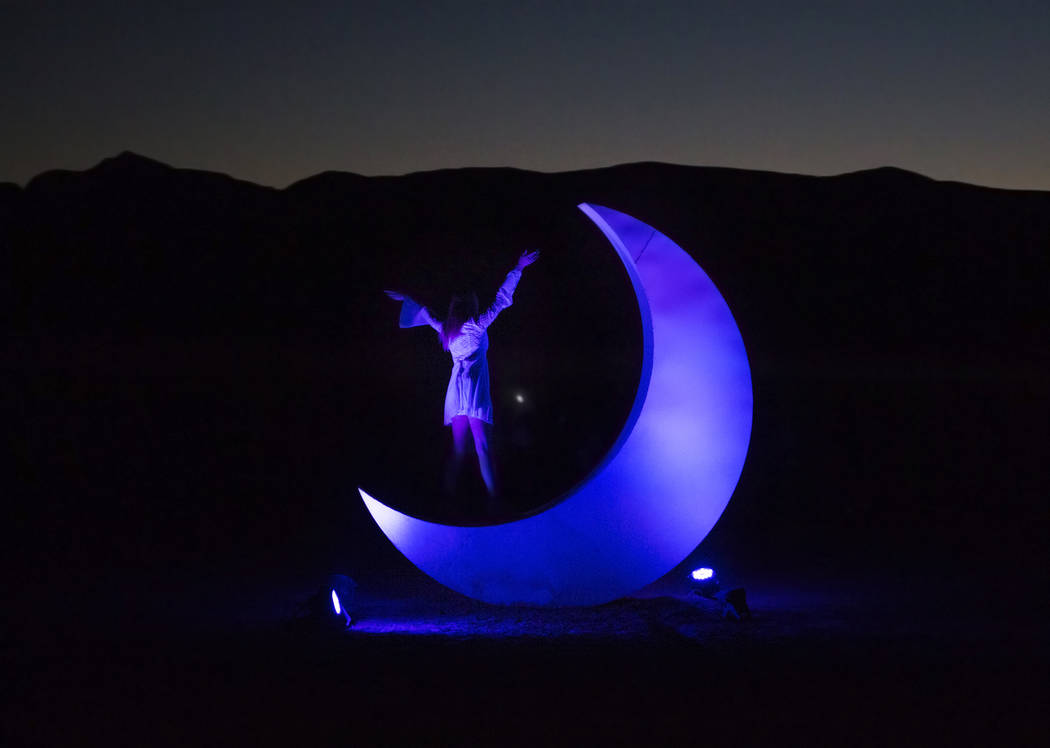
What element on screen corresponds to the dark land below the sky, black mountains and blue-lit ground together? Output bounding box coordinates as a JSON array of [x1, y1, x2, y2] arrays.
[[0, 153, 1050, 746]]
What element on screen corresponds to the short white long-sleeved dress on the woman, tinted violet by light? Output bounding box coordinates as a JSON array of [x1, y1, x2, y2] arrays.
[[400, 269, 522, 425]]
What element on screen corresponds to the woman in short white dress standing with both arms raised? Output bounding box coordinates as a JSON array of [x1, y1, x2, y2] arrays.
[[386, 252, 540, 498]]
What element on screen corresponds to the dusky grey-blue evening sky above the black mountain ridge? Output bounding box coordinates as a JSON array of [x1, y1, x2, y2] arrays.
[[0, 0, 1050, 190]]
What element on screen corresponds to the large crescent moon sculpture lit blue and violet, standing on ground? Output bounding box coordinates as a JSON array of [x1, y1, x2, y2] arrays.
[[359, 203, 753, 605]]
